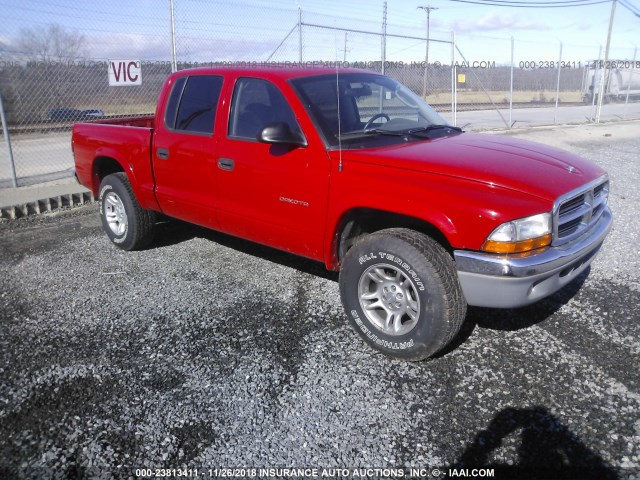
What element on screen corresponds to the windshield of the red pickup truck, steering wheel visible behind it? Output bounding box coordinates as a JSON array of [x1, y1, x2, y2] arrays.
[[292, 73, 454, 146]]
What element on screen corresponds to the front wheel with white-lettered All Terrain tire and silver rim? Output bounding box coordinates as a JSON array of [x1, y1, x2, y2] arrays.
[[340, 228, 466, 360]]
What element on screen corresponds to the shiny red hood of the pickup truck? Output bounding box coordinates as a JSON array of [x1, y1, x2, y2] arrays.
[[343, 133, 605, 201]]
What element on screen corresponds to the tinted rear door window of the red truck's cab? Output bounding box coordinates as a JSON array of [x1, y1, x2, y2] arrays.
[[170, 75, 222, 134]]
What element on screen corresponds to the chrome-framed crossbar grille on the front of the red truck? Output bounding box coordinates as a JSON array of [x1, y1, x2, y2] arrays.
[[553, 179, 609, 245]]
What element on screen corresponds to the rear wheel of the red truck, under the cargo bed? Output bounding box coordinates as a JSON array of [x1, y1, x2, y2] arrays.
[[99, 172, 156, 250]]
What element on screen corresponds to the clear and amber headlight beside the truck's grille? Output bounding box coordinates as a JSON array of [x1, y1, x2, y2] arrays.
[[482, 213, 551, 253]]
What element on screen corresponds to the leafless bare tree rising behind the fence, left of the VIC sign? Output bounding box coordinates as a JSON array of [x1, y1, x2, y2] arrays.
[[17, 24, 86, 62]]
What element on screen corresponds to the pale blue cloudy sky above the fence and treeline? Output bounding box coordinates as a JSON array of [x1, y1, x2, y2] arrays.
[[0, 0, 640, 64]]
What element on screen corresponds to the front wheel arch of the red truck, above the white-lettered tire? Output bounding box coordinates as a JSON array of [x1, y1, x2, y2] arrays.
[[326, 208, 457, 270]]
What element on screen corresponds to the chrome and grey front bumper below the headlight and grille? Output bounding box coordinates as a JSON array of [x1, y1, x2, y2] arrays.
[[453, 208, 612, 308]]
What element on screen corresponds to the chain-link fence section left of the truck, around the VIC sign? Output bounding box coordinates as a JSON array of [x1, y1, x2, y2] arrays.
[[0, 0, 178, 188]]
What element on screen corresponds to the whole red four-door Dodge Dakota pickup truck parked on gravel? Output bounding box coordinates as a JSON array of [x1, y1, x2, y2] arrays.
[[72, 68, 612, 360]]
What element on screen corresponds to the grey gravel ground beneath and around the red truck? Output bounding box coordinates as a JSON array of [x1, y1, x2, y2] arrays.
[[0, 123, 640, 479]]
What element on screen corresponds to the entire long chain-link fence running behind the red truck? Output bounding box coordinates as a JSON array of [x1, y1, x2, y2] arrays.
[[0, 0, 640, 188]]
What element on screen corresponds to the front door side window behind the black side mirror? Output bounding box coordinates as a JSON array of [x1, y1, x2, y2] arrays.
[[229, 78, 300, 140]]
